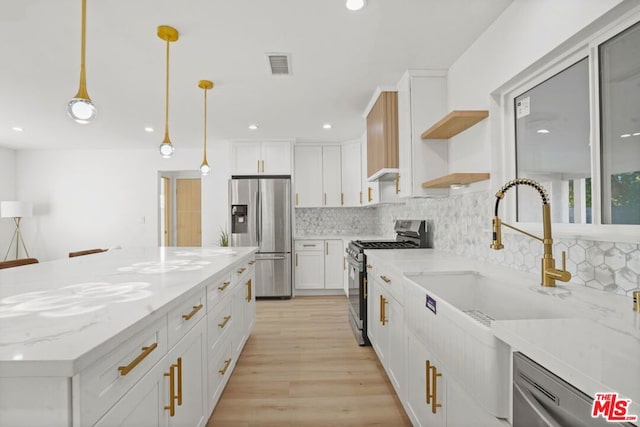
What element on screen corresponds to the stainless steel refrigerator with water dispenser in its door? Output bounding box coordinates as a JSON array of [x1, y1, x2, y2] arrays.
[[229, 176, 293, 298]]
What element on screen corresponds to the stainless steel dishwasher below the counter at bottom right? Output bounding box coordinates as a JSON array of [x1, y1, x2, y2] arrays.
[[513, 352, 635, 427]]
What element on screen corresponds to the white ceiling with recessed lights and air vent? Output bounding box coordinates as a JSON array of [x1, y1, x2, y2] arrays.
[[0, 0, 512, 150]]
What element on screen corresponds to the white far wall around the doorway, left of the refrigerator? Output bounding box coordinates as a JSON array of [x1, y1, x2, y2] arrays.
[[15, 143, 229, 261]]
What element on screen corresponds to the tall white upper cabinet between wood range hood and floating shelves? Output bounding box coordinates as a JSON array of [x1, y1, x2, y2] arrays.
[[398, 70, 448, 197]]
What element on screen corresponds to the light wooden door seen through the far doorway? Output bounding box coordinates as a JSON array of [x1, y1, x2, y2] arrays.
[[176, 178, 202, 246]]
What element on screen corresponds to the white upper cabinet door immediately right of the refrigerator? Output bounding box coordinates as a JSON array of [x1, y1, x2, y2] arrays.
[[294, 145, 323, 208]]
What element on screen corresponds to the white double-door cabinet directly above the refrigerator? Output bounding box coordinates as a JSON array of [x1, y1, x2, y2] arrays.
[[231, 141, 292, 175]]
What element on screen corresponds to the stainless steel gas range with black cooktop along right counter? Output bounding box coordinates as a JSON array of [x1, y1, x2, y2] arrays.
[[346, 219, 433, 345]]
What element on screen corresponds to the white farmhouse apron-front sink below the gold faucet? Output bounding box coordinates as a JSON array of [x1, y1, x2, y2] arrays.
[[405, 271, 572, 418]]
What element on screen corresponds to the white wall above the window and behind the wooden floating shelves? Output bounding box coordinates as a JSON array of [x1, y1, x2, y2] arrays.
[[448, 0, 638, 176]]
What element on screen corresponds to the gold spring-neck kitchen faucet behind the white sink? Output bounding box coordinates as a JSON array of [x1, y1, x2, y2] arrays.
[[491, 178, 571, 286]]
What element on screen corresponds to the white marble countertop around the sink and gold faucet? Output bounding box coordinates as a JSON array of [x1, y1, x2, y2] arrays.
[[367, 249, 640, 416]]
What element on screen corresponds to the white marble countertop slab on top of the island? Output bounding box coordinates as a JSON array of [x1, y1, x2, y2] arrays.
[[0, 247, 257, 376]]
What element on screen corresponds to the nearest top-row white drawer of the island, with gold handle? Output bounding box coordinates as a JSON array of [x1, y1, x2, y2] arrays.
[[78, 317, 168, 426]]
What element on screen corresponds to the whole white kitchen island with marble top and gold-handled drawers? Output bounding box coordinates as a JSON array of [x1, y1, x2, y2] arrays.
[[0, 248, 256, 426]]
